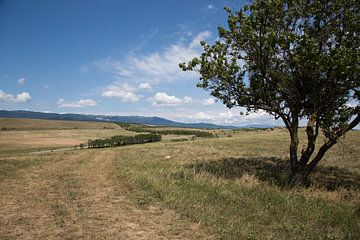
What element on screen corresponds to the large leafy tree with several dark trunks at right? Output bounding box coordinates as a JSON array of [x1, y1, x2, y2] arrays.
[[180, 0, 360, 184]]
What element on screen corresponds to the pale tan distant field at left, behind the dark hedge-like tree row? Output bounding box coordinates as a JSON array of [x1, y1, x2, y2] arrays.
[[0, 118, 135, 155]]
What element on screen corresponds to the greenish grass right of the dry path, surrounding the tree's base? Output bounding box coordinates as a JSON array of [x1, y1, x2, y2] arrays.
[[114, 130, 360, 239]]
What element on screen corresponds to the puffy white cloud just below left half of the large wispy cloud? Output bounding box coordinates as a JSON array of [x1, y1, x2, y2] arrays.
[[101, 84, 140, 102]]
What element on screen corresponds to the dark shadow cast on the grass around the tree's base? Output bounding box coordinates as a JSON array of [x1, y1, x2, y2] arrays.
[[186, 157, 360, 191]]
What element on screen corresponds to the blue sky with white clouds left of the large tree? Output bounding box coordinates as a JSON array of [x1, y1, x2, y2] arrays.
[[0, 0, 275, 125]]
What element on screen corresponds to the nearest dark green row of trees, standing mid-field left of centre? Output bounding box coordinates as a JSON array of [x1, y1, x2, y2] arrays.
[[87, 133, 161, 148]]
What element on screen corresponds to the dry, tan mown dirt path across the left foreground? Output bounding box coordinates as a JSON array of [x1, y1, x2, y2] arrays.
[[0, 149, 205, 239]]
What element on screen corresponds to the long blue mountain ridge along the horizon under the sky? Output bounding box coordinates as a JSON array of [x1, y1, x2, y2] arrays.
[[0, 110, 238, 129]]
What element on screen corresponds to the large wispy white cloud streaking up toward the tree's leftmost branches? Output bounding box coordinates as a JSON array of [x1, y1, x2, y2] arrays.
[[93, 31, 211, 84]]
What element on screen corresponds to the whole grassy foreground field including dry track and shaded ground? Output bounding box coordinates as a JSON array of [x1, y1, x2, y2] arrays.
[[0, 119, 360, 239]]
